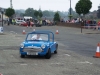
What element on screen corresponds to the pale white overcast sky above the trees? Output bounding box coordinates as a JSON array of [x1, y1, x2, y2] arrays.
[[0, 0, 100, 11]]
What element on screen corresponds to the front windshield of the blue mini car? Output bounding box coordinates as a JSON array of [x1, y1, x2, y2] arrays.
[[26, 34, 48, 41]]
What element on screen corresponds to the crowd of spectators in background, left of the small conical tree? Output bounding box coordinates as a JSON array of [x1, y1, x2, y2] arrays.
[[5, 18, 56, 26]]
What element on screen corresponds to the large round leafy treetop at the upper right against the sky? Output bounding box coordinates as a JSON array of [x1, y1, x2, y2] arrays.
[[75, 0, 92, 15]]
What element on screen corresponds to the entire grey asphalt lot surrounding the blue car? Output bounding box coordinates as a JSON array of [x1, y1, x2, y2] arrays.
[[0, 26, 100, 75]]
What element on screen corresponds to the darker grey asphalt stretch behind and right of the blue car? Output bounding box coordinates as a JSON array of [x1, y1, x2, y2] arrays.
[[4, 26, 100, 57]]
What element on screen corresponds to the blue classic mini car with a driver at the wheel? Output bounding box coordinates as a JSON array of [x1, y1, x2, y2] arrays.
[[20, 31, 58, 59]]
